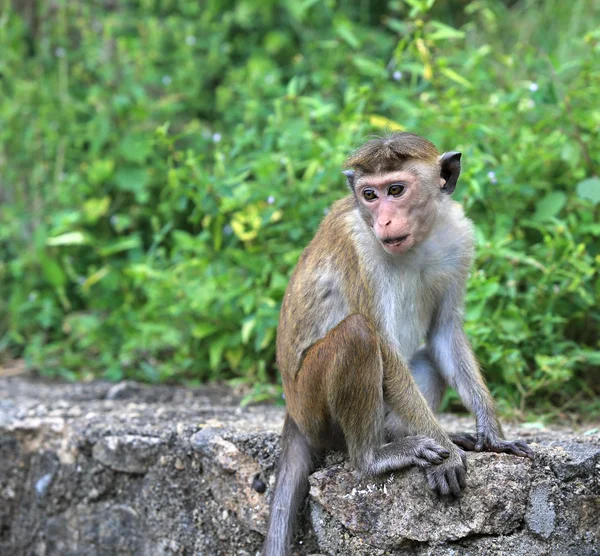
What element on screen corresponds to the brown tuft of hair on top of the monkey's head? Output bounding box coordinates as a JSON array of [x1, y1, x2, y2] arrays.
[[344, 132, 439, 174]]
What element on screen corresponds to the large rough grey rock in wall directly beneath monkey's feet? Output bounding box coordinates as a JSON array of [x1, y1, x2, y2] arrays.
[[310, 454, 531, 549]]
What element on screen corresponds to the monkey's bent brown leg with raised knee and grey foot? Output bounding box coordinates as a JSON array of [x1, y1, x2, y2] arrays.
[[304, 314, 449, 475]]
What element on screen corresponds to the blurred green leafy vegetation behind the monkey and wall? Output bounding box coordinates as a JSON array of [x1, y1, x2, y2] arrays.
[[0, 0, 600, 417]]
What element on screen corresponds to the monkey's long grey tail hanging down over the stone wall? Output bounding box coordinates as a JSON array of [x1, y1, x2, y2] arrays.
[[263, 414, 312, 556]]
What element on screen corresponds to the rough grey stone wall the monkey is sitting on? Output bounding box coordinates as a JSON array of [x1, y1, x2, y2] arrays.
[[0, 377, 600, 556]]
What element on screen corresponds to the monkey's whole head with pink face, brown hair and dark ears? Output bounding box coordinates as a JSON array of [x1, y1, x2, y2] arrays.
[[344, 133, 461, 255]]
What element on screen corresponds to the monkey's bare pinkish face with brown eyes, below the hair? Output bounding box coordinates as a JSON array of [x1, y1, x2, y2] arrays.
[[355, 168, 445, 255]]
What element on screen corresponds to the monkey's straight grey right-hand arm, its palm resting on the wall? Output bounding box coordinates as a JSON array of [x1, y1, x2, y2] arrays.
[[428, 288, 533, 458]]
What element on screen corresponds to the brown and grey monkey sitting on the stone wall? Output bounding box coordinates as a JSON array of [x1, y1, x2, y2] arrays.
[[263, 132, 533, 556]]
